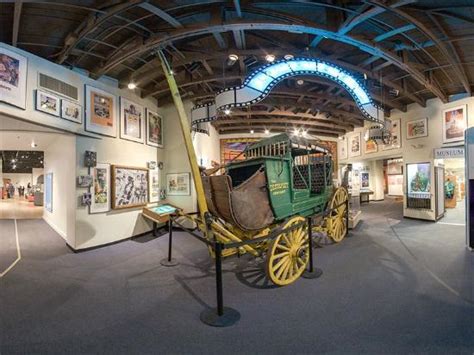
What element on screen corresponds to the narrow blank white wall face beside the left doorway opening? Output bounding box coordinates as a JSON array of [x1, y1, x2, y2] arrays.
[[43, 134, 76, 246]]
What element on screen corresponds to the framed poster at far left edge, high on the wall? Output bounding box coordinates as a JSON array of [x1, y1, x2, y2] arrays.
[[0, 48, 28, 110]]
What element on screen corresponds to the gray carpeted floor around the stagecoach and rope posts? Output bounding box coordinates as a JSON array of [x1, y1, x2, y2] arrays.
[[0, 202, 474, 355]]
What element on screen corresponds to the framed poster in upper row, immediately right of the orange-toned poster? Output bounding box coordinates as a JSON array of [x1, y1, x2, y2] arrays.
[[120, 97, 145, 143]]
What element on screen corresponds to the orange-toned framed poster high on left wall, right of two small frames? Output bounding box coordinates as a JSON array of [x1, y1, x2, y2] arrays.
[[85, 85, 117, 137]]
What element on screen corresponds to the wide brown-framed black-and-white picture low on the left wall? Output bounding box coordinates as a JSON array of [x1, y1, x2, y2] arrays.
[[112, 165, 148, 209]]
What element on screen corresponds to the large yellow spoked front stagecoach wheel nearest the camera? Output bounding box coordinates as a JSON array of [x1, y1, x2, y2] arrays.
[[267, 217, 309, 286]]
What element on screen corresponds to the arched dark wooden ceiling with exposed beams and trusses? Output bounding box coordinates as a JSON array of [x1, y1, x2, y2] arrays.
[[0, 0, 474, 135]]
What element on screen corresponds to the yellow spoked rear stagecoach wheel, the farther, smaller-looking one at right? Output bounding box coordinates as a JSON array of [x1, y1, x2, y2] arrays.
[[326, 187, 348, 243]]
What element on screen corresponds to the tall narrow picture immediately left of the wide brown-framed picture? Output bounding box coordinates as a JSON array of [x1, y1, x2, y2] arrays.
[[89, 163, 110, 213]]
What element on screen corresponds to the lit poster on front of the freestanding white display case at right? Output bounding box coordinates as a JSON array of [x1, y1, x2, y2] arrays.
[[406, 163, 431, 209]]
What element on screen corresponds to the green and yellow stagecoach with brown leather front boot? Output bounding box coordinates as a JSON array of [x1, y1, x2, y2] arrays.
[[181, 134, 348, 286]]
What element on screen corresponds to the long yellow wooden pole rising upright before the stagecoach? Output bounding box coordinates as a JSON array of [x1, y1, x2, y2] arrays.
[[158, 51, 208, 221]]
